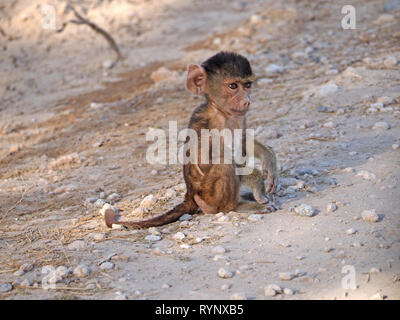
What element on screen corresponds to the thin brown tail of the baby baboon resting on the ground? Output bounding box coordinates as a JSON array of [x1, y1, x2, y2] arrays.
[[104, 199, 198, 229]]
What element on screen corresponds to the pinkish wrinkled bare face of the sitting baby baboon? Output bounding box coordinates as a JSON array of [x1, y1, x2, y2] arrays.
[[205, 76, 253, 116]]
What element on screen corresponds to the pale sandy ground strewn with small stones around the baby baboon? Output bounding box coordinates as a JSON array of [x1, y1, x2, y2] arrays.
[[0, 0, 400, 299]]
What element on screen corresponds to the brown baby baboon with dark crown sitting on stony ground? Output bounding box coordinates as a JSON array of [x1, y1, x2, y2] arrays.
[[105, 52, 278, 229]]
